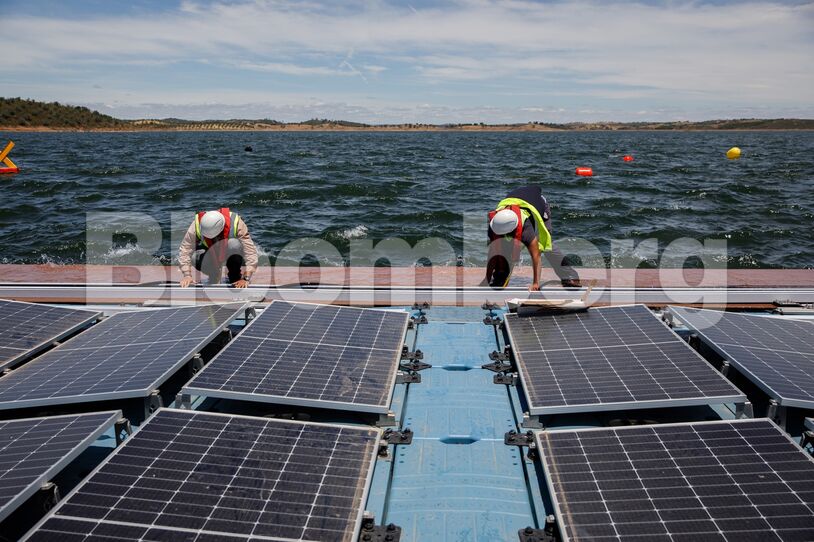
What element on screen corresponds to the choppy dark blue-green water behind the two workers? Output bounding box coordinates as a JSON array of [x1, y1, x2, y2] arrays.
[[0, 132, 814, 267]]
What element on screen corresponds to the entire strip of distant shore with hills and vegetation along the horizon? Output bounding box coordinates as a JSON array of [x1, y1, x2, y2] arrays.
[[0, 97, 814, 132]]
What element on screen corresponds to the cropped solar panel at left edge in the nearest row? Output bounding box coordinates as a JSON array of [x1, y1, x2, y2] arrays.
[[0, 411, 121, 521]]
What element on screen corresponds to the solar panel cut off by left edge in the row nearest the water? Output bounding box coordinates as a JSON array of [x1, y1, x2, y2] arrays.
[[0, 299, 101, 369]]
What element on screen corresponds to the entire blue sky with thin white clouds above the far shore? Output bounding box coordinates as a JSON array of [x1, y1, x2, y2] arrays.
[[0, 0, 814, 124]]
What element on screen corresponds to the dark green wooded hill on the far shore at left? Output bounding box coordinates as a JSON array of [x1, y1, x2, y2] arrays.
[[0, 98, 130, 129]]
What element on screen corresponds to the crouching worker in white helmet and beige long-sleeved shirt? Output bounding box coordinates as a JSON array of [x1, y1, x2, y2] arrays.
[[178, 207, 257, 288]]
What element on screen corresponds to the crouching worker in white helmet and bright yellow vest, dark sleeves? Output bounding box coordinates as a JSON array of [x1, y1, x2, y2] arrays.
[[486, 186, 580, 290]]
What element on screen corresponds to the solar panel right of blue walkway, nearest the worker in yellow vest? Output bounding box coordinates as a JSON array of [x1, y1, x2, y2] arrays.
[[506, 305, 746, 415]]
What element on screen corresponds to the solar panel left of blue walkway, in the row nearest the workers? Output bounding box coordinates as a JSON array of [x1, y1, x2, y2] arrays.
[[184, 301, 409, 413]]
